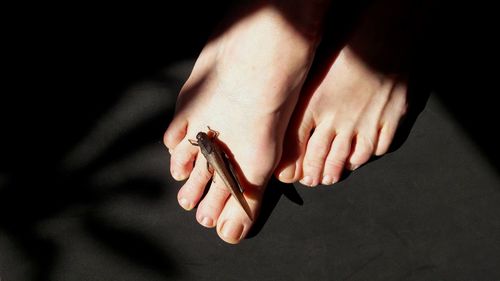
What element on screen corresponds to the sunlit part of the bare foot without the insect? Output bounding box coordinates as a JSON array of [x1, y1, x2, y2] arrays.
[[275, 47, 407, 186]]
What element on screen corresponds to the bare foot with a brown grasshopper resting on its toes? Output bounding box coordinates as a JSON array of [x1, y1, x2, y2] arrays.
[[164, 1, 328, 243]]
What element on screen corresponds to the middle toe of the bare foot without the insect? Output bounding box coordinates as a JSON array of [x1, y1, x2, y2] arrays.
[[322, 133, 351, 185]]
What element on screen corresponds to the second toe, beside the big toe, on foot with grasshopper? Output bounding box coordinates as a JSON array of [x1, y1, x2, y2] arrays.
[[196, 173, 231, 227]]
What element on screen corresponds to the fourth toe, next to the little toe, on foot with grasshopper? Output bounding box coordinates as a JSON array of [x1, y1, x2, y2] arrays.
[[170, 140, 199, 181]]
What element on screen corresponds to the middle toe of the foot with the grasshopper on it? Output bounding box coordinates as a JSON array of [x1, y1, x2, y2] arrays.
[[177, 157, 212, 211]]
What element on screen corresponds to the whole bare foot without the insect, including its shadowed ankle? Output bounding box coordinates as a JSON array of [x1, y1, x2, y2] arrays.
[[275, 0, 420, 186]]
